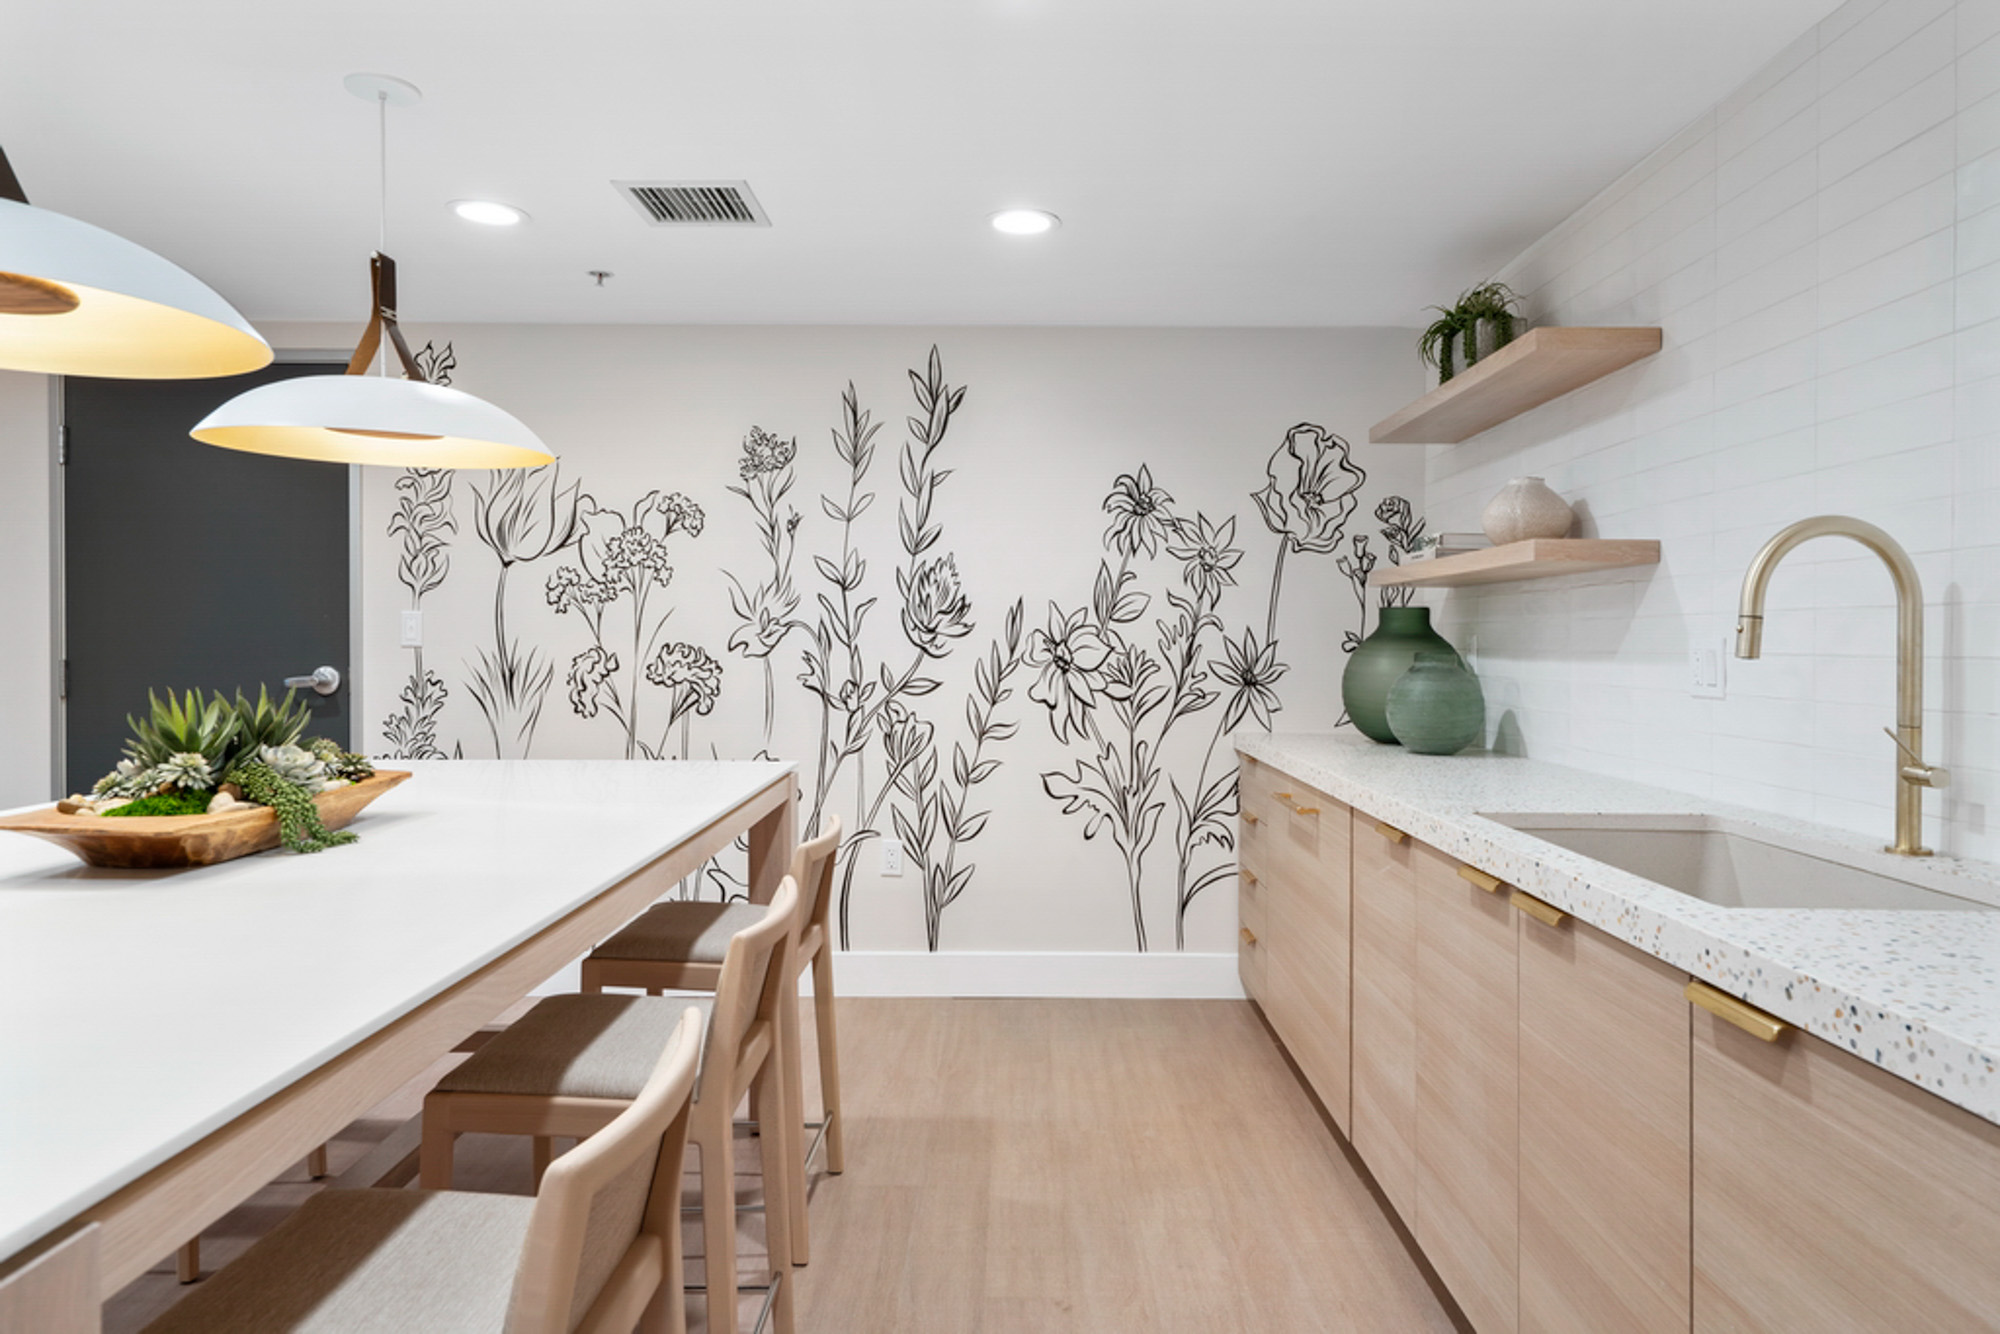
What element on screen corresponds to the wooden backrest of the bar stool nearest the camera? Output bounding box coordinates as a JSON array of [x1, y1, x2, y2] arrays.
[[506, 1006, 702, 1334]]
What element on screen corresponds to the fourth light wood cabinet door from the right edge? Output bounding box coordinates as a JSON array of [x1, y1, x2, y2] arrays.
[[1348, 812, 1440, 1230]]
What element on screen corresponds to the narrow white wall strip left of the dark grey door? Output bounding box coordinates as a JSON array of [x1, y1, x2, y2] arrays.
[[0, 370, 54, 808]]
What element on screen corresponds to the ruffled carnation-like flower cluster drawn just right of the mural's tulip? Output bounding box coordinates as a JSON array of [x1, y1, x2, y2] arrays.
[[544, 490, 720, 760]]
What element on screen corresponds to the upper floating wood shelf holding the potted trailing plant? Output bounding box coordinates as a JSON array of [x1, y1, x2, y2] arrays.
[[1368, 328, 1660, 444]]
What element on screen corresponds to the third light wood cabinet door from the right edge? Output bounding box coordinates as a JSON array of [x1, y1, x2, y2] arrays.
[[1412, 848, 1520, 1334]]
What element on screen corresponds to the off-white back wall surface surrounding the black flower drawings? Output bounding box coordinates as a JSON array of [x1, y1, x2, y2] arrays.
[[276, 326, 1422, 972]]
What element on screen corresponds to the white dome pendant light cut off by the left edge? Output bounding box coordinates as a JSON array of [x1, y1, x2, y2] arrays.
[[0, 150, 270, 380]]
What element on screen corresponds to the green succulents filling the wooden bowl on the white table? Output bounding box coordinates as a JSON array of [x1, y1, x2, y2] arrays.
[[58, 688, 374, 852]]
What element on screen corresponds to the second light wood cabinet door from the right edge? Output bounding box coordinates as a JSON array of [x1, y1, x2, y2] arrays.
[[1518, 912, 1692, 1334]]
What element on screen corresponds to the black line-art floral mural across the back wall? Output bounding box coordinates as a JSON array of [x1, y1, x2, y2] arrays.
[[380, 346, 1426, 952]]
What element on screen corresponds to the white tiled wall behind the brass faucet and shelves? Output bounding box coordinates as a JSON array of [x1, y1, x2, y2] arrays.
[[1426, 0, 2000, 858]]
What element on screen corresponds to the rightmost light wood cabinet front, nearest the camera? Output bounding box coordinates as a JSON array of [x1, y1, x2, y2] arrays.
[[1692, 1010, 2000, 1334]]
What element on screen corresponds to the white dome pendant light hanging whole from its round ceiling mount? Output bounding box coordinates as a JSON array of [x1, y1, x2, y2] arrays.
[[190, 74, 556, 468]]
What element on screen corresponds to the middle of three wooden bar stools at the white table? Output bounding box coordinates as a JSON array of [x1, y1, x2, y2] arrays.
[[418, 876, 798, 1334]]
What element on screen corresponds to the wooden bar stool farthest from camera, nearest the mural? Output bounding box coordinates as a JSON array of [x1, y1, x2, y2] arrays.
[[584, 816, 846, 1264]]
